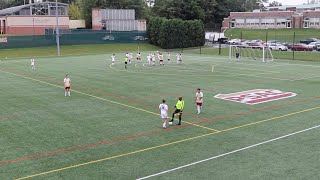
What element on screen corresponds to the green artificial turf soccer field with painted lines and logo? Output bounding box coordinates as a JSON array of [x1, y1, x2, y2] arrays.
[[0, 52, 320, 180]]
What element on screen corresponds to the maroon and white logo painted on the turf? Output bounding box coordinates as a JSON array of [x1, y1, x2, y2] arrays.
[[214, 89, 297, 105]]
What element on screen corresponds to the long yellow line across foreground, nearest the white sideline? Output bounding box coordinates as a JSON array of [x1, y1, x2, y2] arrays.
[[16, 106, 320, 180]]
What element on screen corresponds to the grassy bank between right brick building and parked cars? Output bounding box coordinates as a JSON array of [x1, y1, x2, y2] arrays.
[[225, 28, 320, 42]]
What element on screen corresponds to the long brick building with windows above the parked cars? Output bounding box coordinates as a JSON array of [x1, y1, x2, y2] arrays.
[[222, 4, 320, 30]]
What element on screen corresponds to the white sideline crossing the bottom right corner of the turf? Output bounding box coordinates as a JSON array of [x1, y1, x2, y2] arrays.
[[137, 125, 320, 180]]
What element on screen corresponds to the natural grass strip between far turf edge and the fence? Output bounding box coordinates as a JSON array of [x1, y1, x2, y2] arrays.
[[0, 43, 320, 61]]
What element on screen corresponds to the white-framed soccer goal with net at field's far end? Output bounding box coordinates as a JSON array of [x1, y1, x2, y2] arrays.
[[229, 45, 274, 62]]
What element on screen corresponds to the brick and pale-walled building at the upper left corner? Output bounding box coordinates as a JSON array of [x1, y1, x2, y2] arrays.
[[0, 0, 69, 35]]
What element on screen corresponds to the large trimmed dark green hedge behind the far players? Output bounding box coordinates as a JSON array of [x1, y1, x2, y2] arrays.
[[147, 17, 205, 49]]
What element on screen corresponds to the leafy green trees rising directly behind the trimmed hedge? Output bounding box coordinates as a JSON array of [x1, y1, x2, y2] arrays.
[[152, 0, 268, 28]]
